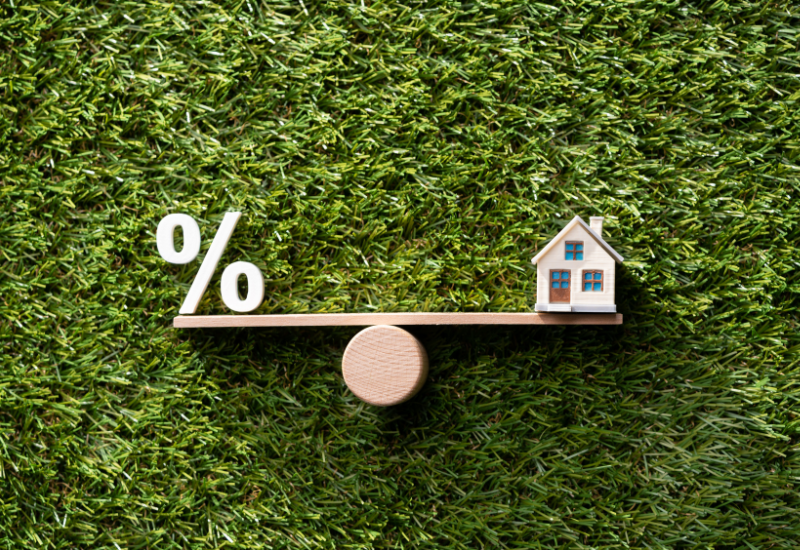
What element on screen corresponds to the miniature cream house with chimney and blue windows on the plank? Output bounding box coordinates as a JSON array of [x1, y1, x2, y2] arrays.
[[531, 216, 623, 313]]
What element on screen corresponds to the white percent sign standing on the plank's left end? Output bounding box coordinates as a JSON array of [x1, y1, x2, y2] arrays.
[[156, 212, 264, 315]]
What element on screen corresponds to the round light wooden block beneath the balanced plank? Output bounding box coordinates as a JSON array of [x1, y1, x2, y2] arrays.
[[342, 325, 428, 407]]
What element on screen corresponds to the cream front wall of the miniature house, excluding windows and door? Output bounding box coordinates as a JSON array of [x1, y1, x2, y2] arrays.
[[536, 225, 617, 305]]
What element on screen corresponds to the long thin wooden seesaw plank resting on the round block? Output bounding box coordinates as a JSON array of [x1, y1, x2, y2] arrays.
[[173, 312, 622, 328]]
